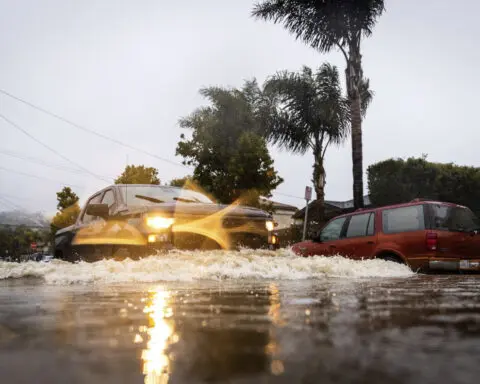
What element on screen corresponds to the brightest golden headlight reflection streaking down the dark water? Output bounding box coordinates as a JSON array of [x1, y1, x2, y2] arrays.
[[142, 287, 178, 384]]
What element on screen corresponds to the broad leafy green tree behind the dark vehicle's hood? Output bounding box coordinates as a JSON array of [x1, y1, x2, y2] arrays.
[[176, 80, 283, 206]]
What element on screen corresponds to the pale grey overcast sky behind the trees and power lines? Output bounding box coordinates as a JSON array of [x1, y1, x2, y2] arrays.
[[0, 0, 480, 213]]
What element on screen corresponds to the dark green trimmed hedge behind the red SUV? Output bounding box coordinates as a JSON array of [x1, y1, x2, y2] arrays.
[[367, 156, 480, 214]]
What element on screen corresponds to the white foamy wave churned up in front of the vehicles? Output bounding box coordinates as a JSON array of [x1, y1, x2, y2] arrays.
[[0, 249, 413, 284]]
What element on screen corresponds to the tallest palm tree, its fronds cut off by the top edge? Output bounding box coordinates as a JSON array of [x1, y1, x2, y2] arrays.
[[253, 0, 385, 208]]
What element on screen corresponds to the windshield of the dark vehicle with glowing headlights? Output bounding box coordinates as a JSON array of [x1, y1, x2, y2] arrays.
[[120, 185, 213, 205]]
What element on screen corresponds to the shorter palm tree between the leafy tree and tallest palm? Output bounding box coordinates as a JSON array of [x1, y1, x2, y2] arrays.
[[264, 63, 349, 220]]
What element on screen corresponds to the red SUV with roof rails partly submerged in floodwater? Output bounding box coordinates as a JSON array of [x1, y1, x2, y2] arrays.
[[293, 199, 480, 271]]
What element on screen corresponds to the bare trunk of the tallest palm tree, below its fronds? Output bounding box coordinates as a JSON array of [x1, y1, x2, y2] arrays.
[[345, 44, 363, 209]]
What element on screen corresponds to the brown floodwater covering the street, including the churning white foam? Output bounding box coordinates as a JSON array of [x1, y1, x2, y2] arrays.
[[0, 250, 480, 384]]
